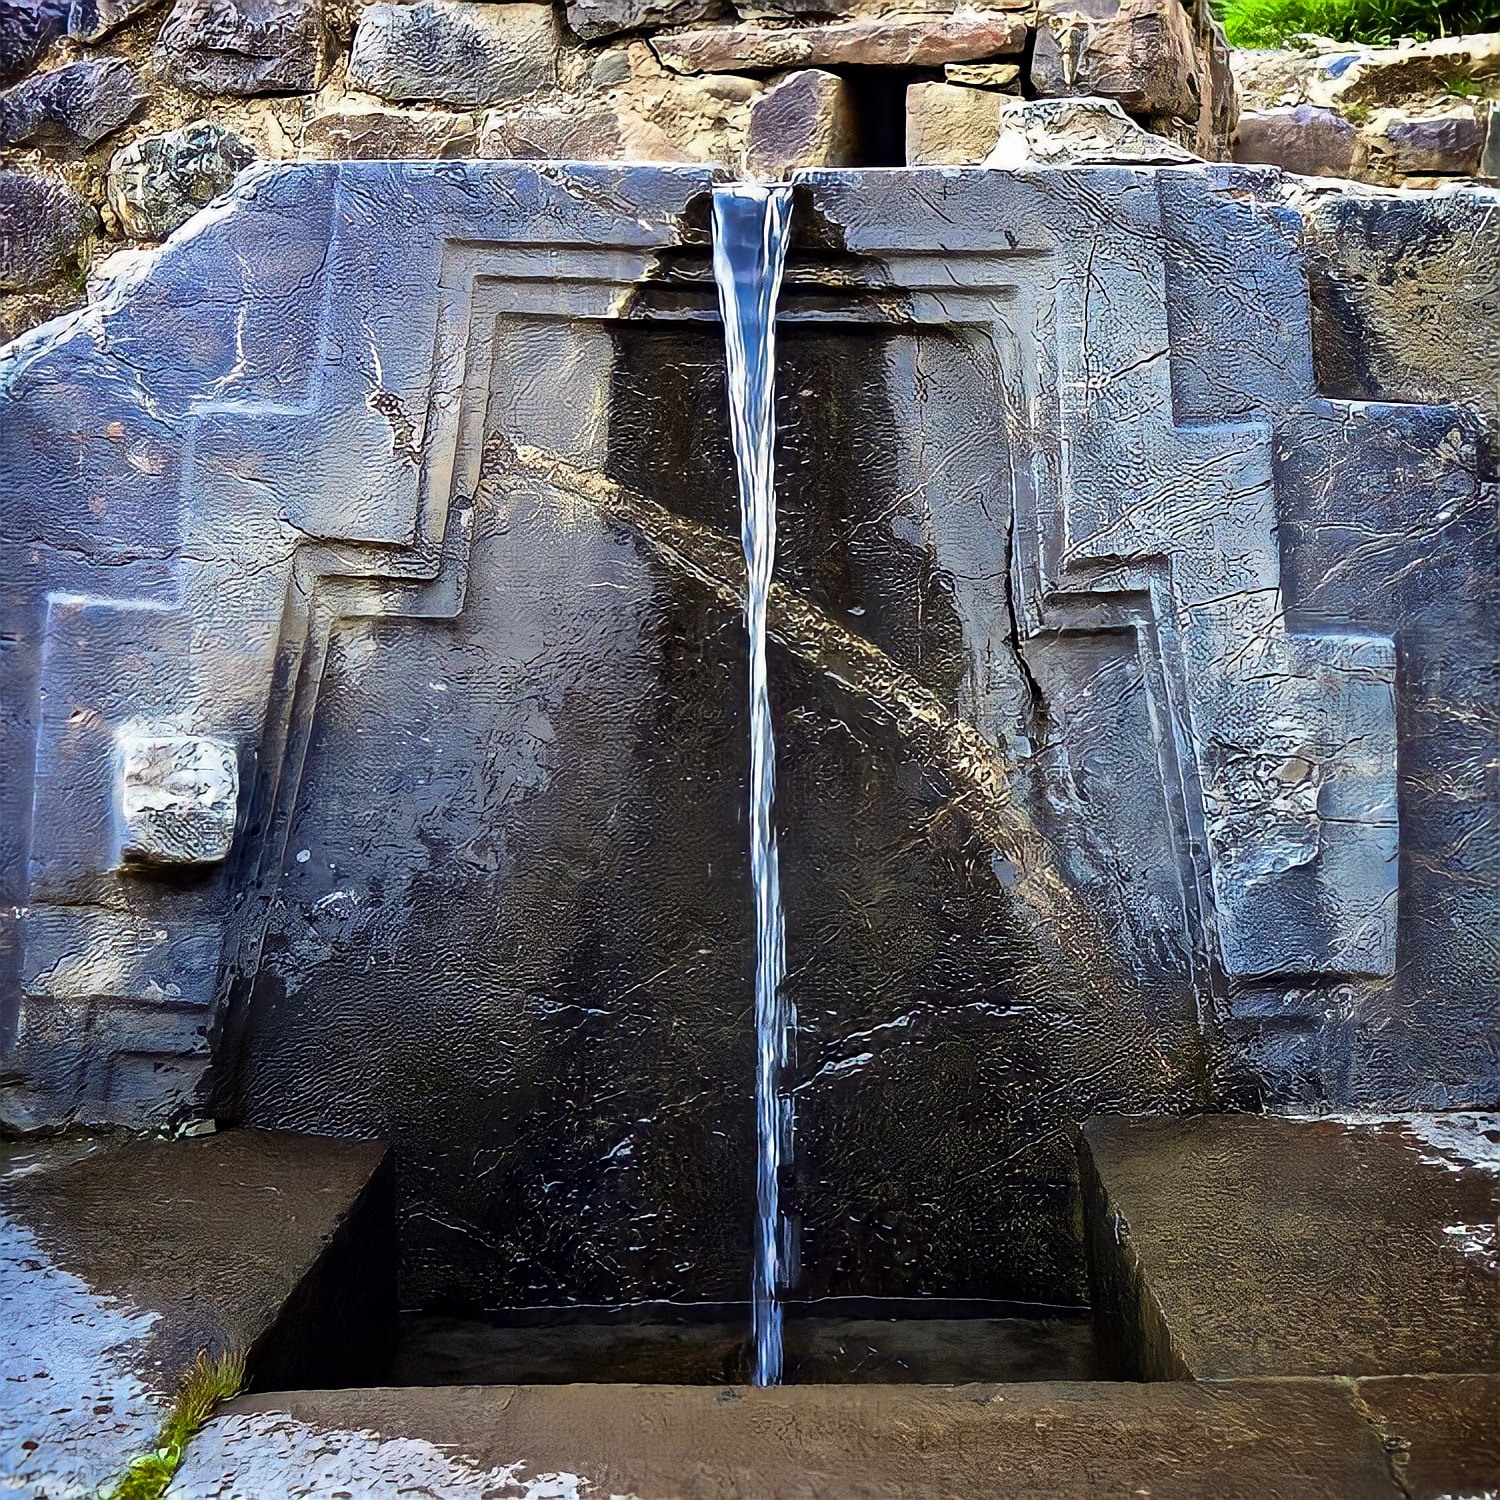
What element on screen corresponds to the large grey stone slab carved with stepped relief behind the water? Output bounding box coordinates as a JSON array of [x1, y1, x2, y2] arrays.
[[0, 162, 1496, 1301]]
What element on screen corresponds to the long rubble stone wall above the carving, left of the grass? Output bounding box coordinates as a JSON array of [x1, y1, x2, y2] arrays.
[[0, 0, 1235, 341]]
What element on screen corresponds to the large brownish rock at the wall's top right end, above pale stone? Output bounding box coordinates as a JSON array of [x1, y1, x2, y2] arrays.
[[1031, 0, 1206, 120]]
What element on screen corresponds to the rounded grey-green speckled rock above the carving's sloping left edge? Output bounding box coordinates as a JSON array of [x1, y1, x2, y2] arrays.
[[105, 120, 255, 240]]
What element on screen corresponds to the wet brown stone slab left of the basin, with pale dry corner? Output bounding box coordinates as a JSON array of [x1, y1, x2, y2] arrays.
[[0, 1131, 395, 1496]]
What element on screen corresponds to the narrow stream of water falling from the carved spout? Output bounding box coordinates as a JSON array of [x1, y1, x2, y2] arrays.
[[714, 183, 797, 1386]]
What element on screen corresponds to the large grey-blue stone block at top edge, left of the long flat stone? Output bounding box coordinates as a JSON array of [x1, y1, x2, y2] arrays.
[[350, 0, 563, 110]]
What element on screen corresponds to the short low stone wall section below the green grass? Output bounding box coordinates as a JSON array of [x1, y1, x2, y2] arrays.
[[1232, 35, 1500, 189]]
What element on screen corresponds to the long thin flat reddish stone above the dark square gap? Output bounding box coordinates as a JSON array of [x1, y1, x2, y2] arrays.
[[653, 8, 1028, 74]]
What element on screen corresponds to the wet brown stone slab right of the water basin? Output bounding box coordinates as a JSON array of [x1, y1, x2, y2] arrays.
[[1083, 1113, 1500, 1380]]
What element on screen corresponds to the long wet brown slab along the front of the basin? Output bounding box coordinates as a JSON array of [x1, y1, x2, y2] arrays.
[[171, 1382, 1400, 1500]]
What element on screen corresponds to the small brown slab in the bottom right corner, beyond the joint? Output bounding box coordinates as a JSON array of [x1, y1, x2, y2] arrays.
[[1356, 1376, 1500, 1500]]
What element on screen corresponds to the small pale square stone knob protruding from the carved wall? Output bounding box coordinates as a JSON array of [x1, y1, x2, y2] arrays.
[[120, 732, 240, 864]]
